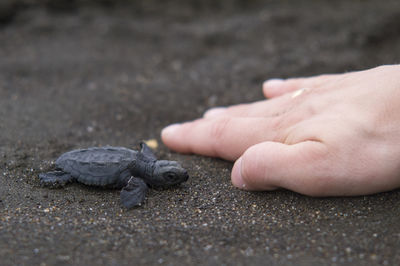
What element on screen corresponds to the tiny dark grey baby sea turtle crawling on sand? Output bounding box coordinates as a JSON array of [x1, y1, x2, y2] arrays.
[[39, 142, 189, 208]]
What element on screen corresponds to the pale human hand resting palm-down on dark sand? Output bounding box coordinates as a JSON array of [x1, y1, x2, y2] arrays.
[[161, 65, 400, 196]]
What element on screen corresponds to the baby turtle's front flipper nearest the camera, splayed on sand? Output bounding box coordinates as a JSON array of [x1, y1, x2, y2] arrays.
[[121, 176, 148, 209]]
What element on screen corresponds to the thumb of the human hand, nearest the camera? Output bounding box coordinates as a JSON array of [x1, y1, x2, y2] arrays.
[[231, 141, 331, 196]]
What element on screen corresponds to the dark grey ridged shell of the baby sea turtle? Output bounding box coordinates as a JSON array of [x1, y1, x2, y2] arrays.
[[56, 147, 137, 186]]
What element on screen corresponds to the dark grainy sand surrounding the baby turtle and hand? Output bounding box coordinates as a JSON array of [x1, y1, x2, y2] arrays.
[[0, 0, 400, 265]]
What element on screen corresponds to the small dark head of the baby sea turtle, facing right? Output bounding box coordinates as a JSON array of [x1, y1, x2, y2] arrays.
[[146, 160, 189, 187]]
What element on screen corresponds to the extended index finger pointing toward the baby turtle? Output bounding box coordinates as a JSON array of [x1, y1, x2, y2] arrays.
[[161, 116, 295, 160]]
